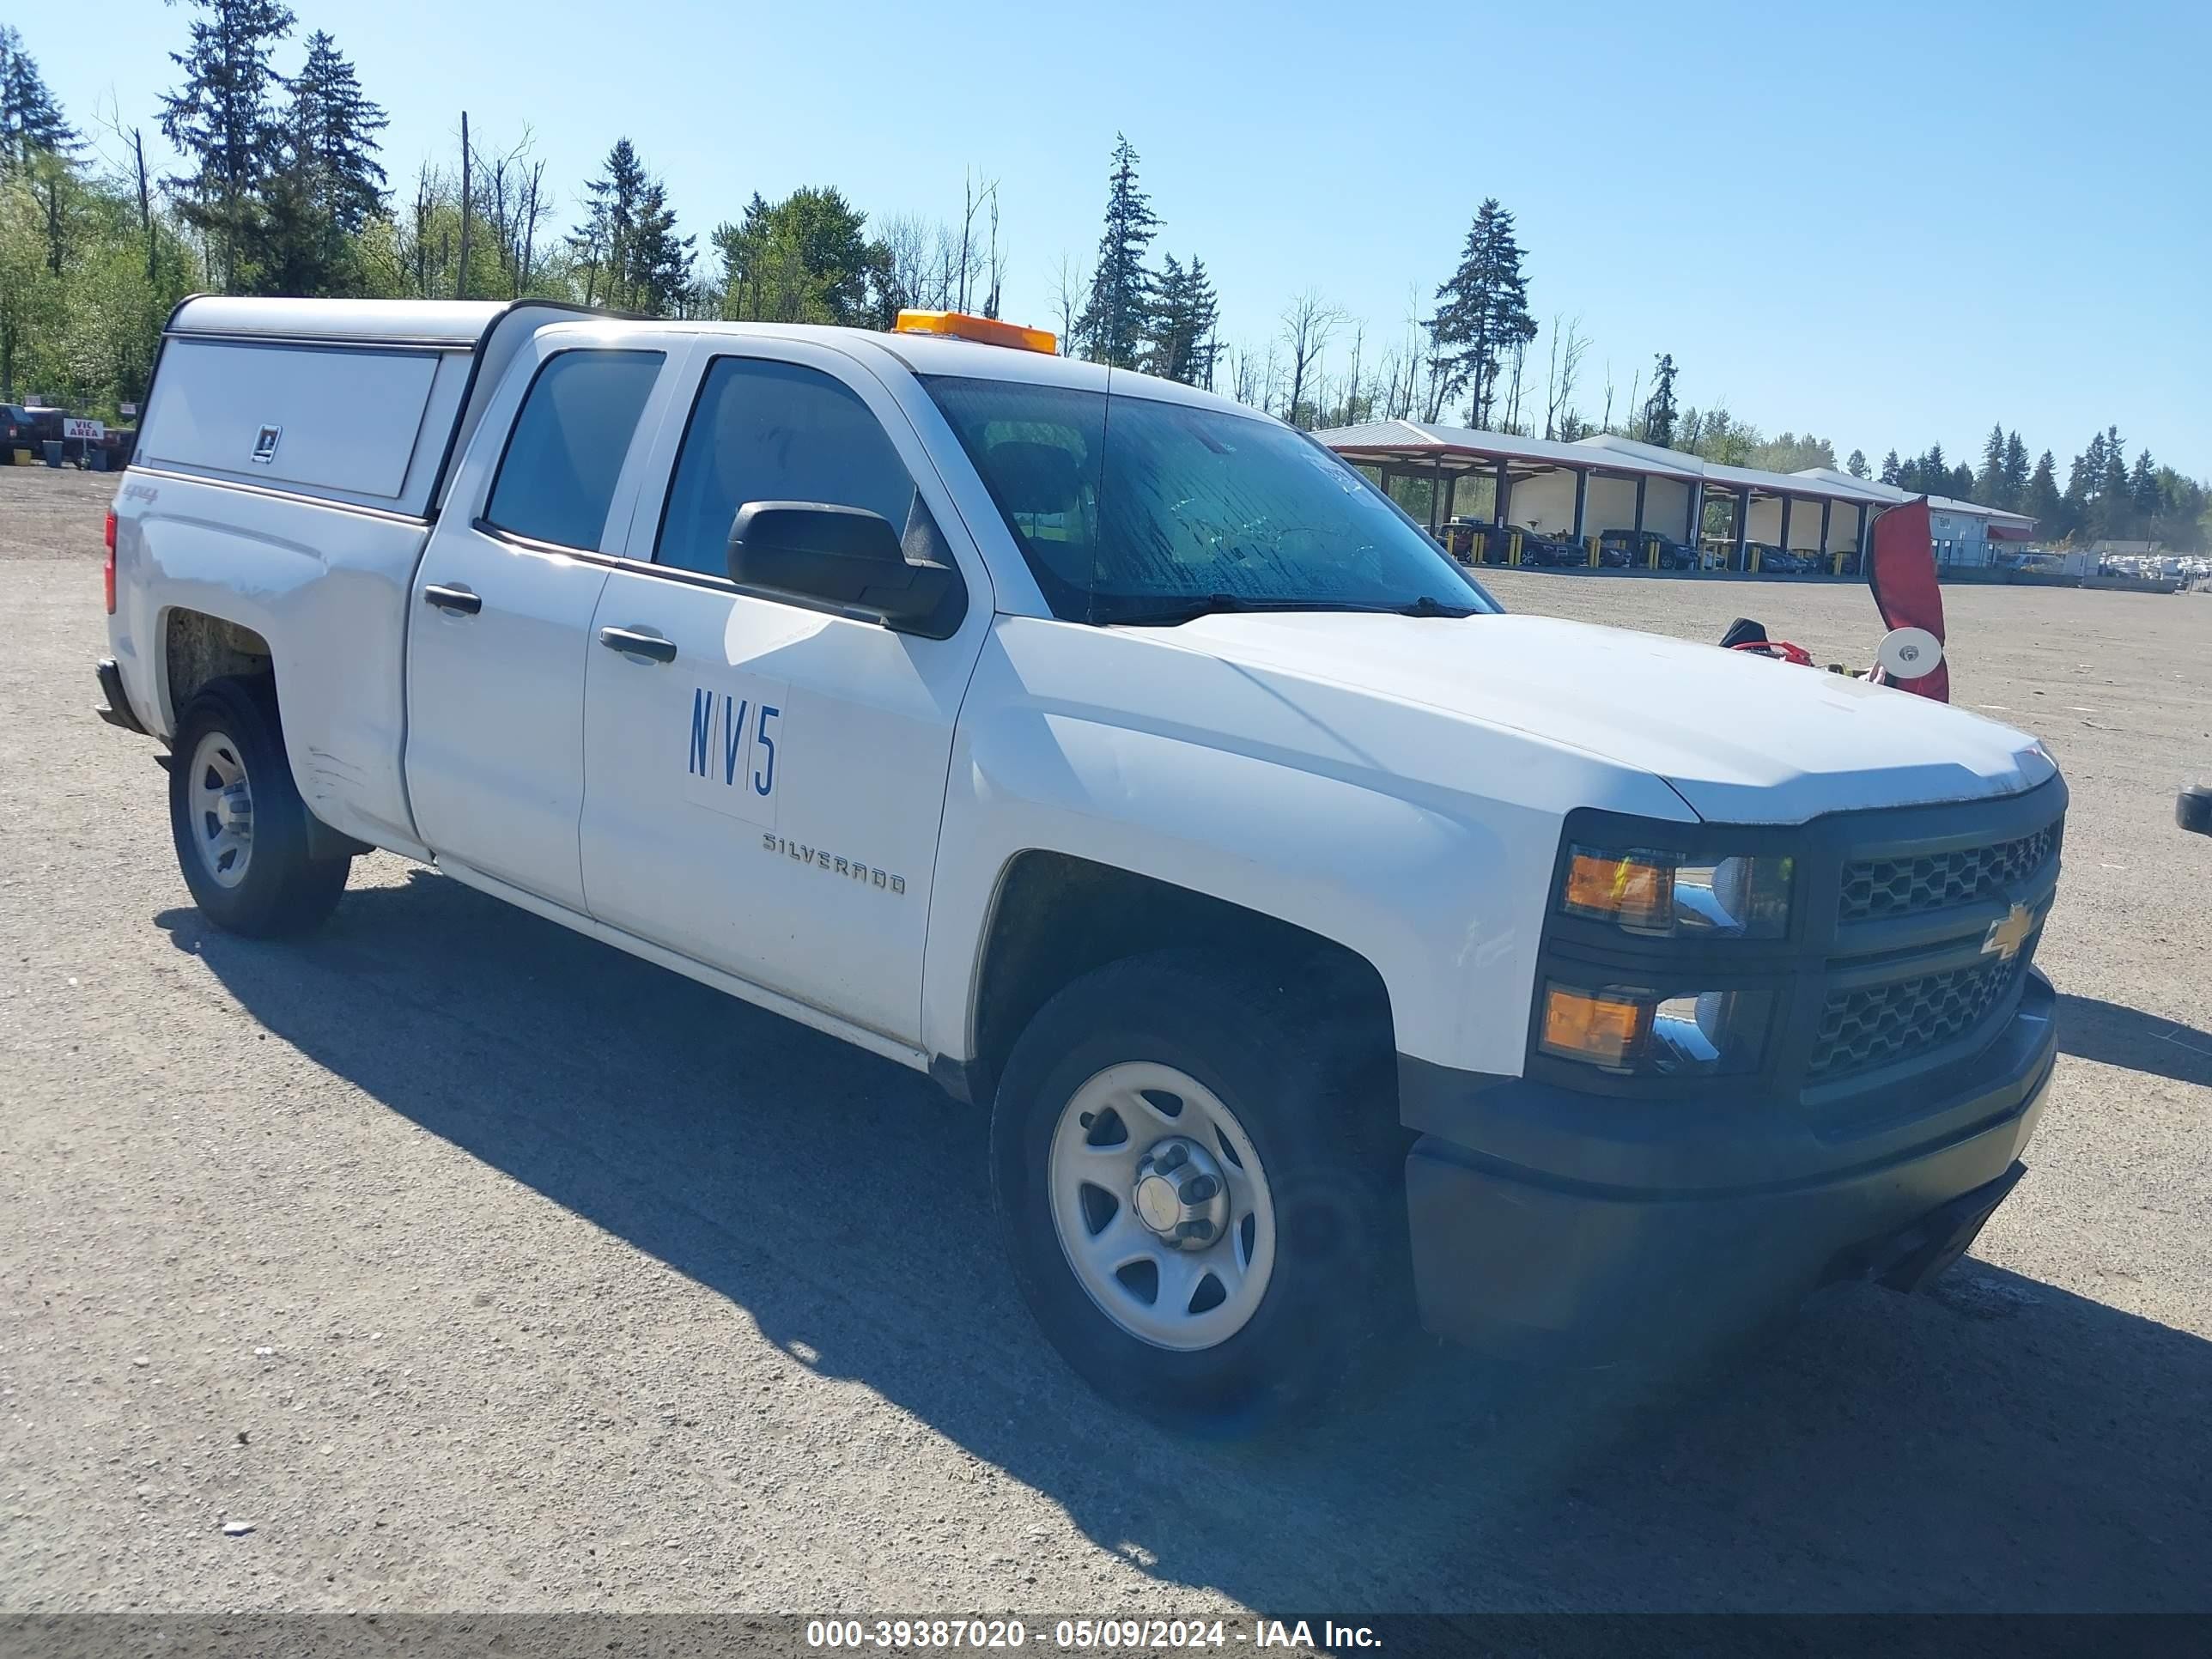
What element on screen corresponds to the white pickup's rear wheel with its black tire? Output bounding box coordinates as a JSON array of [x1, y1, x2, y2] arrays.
[[168, 679, 354, 938]]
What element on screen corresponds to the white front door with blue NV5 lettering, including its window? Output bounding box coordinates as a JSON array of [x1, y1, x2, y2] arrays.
[[581, 341, 991, 1042]]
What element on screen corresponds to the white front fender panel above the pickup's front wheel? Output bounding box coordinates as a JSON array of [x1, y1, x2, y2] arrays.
[[922, 617, 1686, 1075]]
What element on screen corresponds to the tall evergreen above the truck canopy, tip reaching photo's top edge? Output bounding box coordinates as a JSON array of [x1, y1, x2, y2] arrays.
[[161, 0, 292, 288]]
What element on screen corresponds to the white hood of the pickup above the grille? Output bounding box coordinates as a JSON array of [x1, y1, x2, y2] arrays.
[[1172, 611, 2057, 823]]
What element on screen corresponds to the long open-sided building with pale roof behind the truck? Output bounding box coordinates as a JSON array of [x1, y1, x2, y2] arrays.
[[1314, 420, 1891, 571]]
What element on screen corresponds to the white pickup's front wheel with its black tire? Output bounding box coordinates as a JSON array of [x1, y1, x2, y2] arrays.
[[991, 951, 1409, 1433]]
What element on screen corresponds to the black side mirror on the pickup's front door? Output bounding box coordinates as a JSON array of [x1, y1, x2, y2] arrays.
[[728, 502, 967, 639]]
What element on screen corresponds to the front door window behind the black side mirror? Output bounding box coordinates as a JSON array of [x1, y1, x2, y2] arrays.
[[653, 356, 914, 575]]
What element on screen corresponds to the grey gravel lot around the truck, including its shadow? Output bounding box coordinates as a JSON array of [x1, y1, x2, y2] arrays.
[[0, 469, 2212, 1614]]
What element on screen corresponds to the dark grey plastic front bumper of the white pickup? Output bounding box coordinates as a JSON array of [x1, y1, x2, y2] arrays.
[[1401, 973, 2055, 1364]]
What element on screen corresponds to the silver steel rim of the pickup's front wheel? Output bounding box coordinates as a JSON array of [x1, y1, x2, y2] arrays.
[[1046, 1061, 1274, 1352]]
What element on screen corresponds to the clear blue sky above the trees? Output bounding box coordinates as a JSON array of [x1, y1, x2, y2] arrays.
[[15, 0, 2212, 483]]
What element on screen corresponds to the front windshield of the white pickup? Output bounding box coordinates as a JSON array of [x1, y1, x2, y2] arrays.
[[922, 376, 1498, 623]]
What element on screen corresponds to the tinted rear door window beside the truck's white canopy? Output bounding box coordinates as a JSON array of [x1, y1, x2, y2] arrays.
[[484, 347, 664, 553]]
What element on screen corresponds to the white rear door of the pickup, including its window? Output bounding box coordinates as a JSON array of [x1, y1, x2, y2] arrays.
[[407, 334, 668, 911]]
